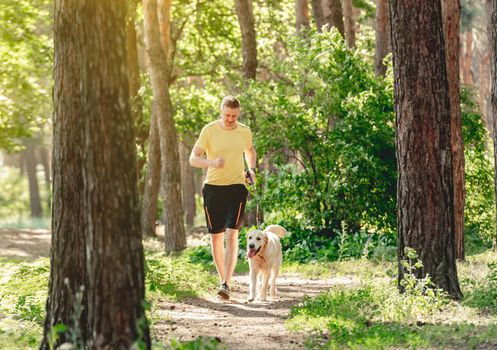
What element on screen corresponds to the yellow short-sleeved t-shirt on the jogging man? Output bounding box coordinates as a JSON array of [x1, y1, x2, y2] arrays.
[[195, 119, 252, 186]]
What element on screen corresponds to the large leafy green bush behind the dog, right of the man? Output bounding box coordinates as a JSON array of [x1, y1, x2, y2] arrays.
[[242, 31, 396, 245]]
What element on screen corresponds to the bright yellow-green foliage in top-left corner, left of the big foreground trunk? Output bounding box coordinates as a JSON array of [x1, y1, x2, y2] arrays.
[[0, 0, 53, 150]]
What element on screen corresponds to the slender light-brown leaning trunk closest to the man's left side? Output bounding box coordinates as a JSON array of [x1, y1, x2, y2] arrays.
[[143, 0, 186, 253]]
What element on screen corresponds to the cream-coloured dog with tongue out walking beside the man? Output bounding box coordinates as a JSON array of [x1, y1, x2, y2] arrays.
[[247, 225, 287, 302]]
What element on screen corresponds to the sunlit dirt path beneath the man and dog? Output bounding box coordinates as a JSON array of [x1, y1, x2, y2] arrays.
[[155, 276, 353, 350]]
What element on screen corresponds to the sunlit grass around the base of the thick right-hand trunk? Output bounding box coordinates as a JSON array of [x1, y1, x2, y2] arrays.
[[287, 251, 497, 349]]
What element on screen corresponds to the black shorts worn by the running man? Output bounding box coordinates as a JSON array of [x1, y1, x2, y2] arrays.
[[202, 184, 248, 233]]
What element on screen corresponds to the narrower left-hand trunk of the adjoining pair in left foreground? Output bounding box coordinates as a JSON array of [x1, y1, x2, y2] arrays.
[[40, 0, 91, 350]]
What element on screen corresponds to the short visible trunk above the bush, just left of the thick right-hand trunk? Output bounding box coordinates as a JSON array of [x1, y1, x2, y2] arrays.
[[374, 0, 390, 77]]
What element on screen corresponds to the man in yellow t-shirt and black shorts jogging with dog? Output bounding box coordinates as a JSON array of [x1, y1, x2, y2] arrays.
[[190, 96, 257, 299]]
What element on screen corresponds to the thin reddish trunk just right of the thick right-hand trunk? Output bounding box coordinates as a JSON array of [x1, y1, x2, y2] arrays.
[[442, 0, 466, 260]]
